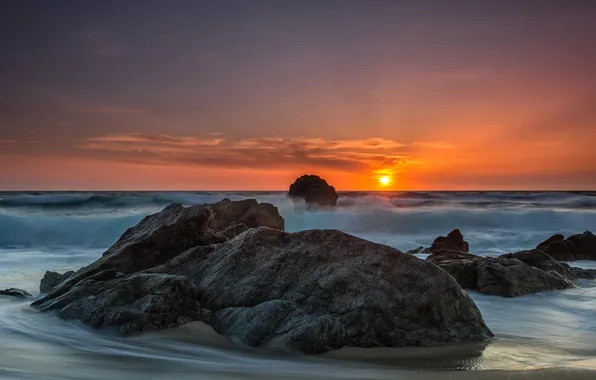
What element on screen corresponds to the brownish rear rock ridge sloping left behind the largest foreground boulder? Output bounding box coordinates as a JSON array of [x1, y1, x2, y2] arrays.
[[35, 198, 284, 304]]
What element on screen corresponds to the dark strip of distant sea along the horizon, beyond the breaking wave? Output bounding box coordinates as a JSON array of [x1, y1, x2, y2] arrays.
[[0, 192, 596, 211]]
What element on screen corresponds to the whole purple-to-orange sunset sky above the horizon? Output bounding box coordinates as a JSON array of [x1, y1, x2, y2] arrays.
[[0, 0, 596, 190]]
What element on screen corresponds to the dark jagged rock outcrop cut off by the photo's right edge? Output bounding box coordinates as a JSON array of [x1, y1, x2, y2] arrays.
[[536, 231, 596, 261]]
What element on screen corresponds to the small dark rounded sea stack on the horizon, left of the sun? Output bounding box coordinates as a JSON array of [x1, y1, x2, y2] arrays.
[[288, 174, 339, 207]]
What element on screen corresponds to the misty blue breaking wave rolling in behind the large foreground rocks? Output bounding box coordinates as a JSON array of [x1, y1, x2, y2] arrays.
[[0, 193, 596, 253]]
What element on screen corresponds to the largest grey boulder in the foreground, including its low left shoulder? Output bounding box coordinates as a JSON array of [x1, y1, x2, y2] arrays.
[[35, 226, 493, 353]]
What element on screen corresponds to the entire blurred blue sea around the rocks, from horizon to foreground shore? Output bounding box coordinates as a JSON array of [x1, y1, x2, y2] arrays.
[[0, 191, 596, 380]]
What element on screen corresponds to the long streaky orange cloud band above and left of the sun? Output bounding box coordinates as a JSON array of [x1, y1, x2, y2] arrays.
[[79, 133, 434, 172]]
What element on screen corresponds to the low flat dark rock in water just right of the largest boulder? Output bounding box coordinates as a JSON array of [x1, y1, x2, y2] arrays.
[[427, 252, 575, 297]]
